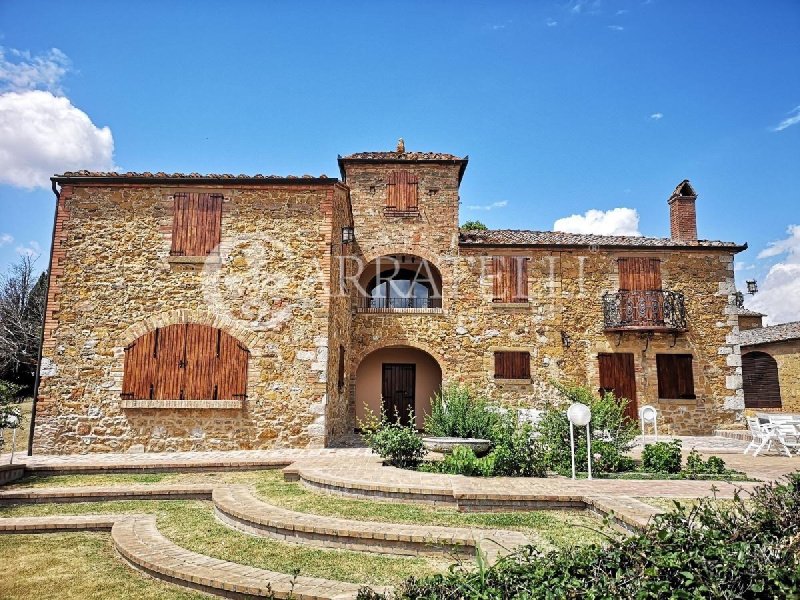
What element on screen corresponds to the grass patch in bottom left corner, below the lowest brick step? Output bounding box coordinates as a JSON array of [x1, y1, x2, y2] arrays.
[[0, 533, 208, 600]]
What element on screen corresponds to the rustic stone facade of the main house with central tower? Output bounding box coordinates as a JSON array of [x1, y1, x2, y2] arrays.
[[34, 153, 743, 453]]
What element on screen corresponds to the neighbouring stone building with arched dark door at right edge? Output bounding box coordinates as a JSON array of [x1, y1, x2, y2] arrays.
[[739, 322, 800, 414]]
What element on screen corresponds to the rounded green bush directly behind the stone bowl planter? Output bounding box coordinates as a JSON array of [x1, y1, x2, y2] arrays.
[[424, 384, 500, 440]]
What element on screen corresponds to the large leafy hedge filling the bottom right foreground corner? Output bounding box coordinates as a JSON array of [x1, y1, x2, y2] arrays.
[[359, 473, 800, 600]]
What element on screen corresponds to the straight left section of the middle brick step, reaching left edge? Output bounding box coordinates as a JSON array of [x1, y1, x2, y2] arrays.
[[0, 483, 214, 505]]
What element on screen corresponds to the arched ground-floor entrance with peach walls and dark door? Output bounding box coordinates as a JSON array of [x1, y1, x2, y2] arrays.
[[355, 346, 442, 429]]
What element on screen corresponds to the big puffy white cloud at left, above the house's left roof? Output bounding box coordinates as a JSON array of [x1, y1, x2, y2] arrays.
[[0, 90, 114, 188]]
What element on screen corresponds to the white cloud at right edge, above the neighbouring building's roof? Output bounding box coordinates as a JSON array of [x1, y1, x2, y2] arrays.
[[747, 225, 800, 323]]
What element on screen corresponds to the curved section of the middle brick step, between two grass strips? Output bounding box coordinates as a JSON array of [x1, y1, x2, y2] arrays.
[[213, 486, 530, 562]]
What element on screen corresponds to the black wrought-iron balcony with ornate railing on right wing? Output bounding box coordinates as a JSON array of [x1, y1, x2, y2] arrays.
[[603, 290, 687, 333]]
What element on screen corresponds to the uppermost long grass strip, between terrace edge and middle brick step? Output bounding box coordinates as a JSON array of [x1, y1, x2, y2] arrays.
[[8, 470, 610, 550]]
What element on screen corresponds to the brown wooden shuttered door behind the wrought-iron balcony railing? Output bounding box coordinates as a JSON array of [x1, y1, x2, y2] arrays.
[[618, 257, 664, 327]]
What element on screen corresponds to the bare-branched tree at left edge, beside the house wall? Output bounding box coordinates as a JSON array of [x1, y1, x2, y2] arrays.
[[0, 256, 47, 386]]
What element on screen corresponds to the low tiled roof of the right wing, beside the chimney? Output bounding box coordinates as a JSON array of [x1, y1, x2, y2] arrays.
[[459, 229, 747, 252]]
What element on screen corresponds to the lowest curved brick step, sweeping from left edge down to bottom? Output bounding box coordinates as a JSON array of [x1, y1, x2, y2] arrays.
[[0, 515, 378, 600]]
